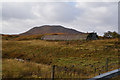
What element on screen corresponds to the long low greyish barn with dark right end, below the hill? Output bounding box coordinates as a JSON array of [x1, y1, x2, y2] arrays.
[[41, 33, 99, 40]]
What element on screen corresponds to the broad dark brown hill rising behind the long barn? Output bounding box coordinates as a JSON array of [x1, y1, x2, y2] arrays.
[[20, 25, 82, 35]]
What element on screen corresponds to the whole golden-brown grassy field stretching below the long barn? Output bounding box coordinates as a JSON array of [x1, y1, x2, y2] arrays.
[[2, 39, 120, 78]]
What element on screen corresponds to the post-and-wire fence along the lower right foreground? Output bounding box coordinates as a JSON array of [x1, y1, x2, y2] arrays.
[[51, 58, 119, 80]]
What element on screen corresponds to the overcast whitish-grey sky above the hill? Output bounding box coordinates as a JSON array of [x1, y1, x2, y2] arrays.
[[0, 2, 118, 35]]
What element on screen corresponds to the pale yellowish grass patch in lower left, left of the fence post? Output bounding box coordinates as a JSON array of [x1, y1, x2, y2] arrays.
[[2, 59, 51, 78]]
